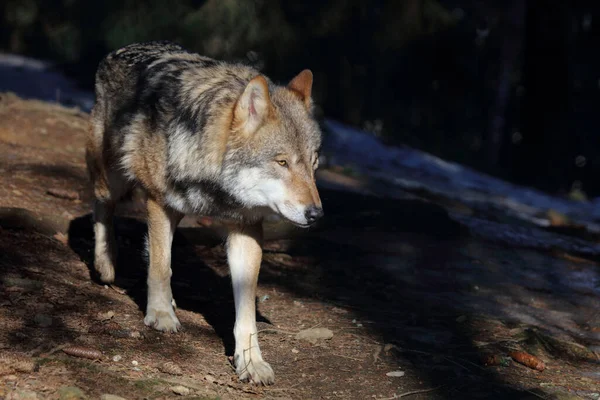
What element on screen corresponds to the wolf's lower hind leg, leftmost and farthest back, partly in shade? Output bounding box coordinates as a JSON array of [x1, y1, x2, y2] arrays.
[[94, 200, 117, 283]]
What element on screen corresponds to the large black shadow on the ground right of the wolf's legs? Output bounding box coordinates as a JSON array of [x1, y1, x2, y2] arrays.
[[268, 190, 548, 399]]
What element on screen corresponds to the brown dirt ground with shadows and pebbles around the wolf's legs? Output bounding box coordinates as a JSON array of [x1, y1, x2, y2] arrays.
[[0, 94, 600, 399]]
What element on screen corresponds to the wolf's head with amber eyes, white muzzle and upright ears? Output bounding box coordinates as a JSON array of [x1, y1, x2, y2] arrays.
[[225, 70, 323, 227]]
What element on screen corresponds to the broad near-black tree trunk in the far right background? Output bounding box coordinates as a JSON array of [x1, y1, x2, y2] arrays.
[[511, 0, 575, 191]]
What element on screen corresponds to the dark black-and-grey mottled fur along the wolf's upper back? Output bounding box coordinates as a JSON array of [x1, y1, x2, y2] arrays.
[[96, 41, 258, 137]]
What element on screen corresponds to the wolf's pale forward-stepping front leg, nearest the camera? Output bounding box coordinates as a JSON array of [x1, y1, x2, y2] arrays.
[[227, 223, 275, 385]]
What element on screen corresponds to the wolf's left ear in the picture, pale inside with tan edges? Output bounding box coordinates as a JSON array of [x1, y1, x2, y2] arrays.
[[233, 75, 271, 134]]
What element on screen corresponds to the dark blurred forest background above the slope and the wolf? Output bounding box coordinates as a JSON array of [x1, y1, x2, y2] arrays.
[[0, 0, 600, 197]]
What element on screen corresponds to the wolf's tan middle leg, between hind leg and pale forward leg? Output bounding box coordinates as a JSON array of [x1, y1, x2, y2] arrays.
[[144, 199, 182, 332]]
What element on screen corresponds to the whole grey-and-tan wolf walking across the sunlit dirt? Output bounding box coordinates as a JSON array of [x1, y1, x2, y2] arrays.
[[86, 41, 323, 384]]
